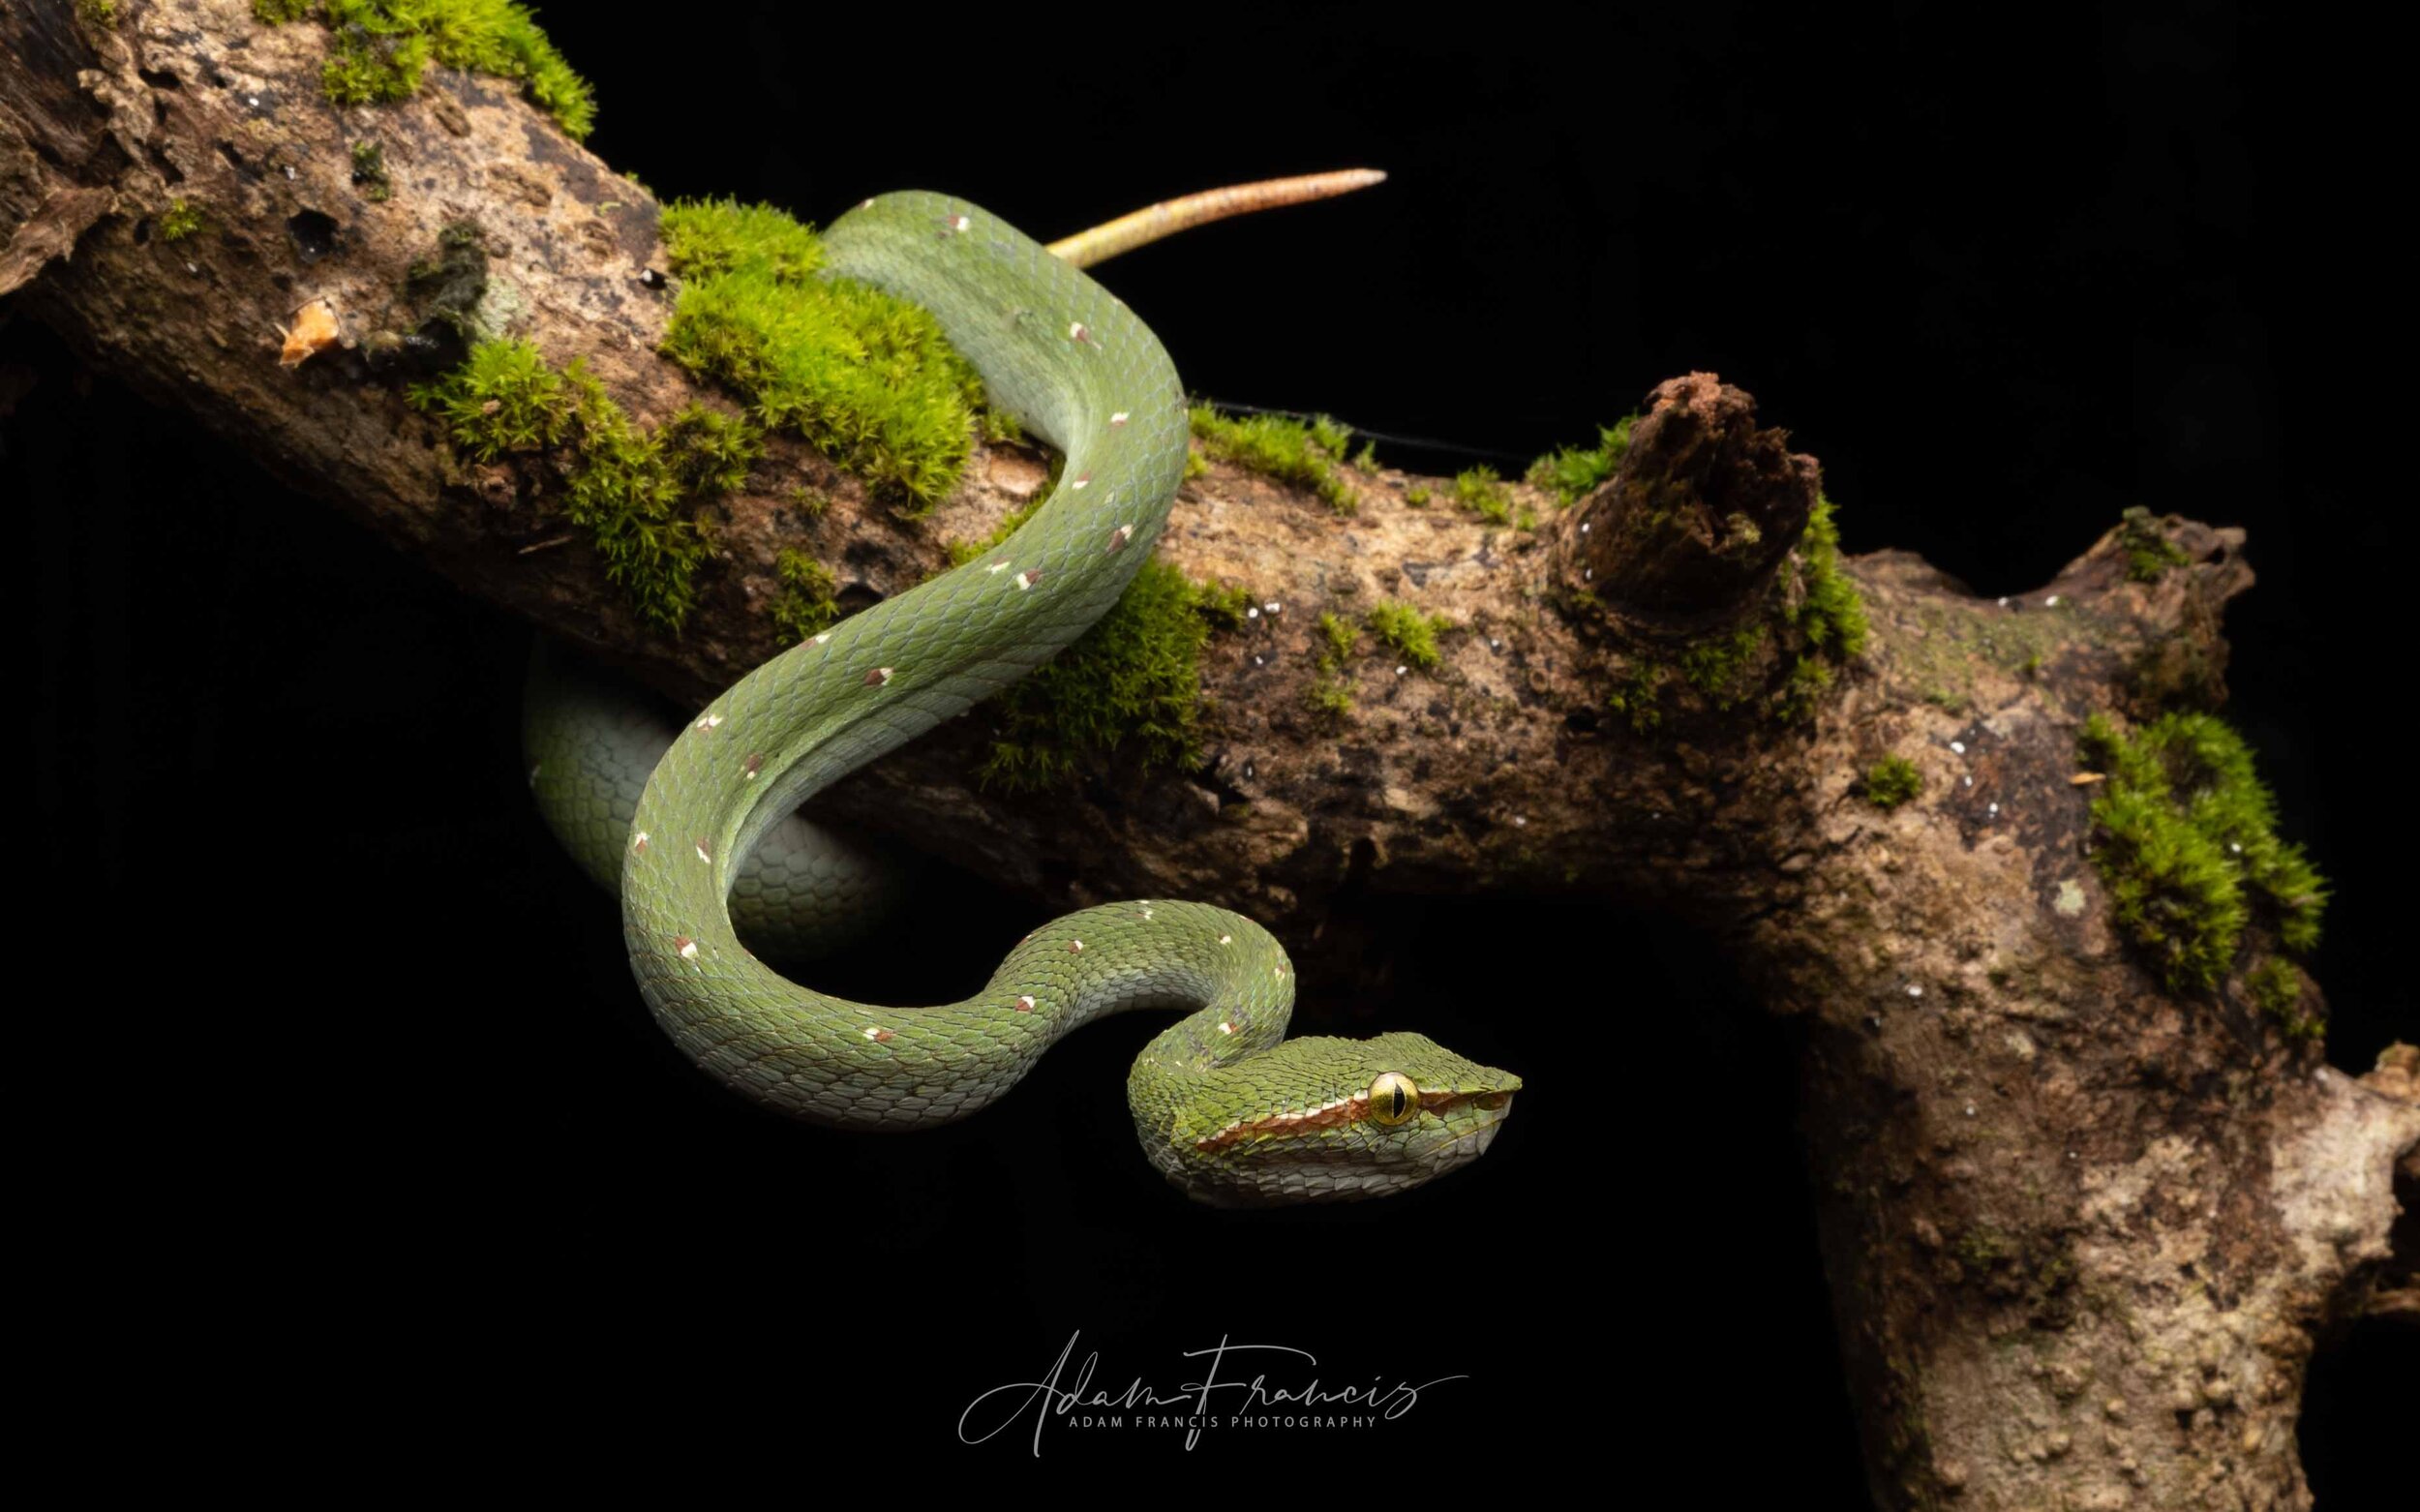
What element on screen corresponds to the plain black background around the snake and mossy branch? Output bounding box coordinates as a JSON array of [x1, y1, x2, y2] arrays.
[[0, 5, 2413, 1507]]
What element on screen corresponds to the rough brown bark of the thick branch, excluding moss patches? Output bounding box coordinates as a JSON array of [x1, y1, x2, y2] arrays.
[[0, 2, 2420, 1507]]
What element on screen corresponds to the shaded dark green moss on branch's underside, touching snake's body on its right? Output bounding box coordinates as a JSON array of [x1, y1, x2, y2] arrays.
[[978, 561, 1218, 789]]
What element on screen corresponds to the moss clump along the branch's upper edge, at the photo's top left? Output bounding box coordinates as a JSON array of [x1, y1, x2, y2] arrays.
[[296, 0, 595, 137]]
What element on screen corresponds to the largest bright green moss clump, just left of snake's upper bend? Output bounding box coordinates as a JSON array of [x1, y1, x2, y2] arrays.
[[663, 200, 983, 513]]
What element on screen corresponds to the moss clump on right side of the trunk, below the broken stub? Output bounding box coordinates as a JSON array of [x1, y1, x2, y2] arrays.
[[2081, 713, 2328, 992]]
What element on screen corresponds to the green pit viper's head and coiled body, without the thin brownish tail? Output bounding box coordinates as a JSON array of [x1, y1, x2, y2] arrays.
[[526, 194, 1520, 1205]]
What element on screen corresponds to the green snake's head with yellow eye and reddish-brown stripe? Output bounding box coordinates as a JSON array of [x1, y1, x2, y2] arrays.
[[1128, 1033, 1520, 1207]]
